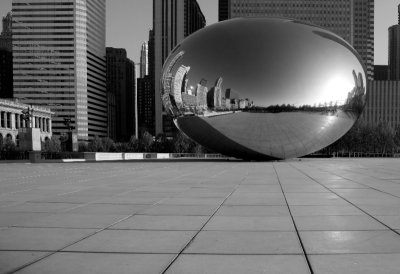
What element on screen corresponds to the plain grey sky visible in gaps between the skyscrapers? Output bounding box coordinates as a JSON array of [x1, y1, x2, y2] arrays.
[[0, 0, 400, 65]]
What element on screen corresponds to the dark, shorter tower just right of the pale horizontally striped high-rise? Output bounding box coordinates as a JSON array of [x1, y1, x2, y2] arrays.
[[106, 47, 136, 142]]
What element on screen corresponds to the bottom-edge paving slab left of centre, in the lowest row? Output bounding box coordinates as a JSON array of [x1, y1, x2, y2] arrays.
[[18, 252, 174, 274]]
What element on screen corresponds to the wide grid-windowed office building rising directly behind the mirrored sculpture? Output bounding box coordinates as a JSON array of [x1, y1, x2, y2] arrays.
[[219, 0, 374, 80]]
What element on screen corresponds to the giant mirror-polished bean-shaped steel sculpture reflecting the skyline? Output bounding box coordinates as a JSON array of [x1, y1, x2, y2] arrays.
[[161, 18, 366, 159]]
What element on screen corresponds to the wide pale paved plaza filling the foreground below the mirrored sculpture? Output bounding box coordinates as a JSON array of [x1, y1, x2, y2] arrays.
[[0, 159, 400, 274]]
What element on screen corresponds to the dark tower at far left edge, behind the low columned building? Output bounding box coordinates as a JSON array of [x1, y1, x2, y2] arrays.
[[0, 12, 13, 98]]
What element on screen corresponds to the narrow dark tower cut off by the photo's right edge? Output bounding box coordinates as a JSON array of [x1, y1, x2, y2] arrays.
[[388, 5, 400, 80]]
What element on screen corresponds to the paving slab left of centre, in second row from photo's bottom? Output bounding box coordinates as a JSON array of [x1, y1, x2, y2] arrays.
[[64, 230, 195, 254]]
